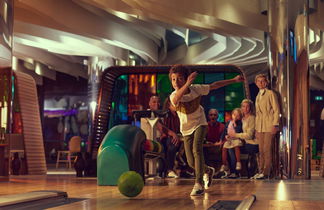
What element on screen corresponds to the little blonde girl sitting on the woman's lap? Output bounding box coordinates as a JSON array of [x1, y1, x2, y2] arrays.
[[220, 108, 243, 175]]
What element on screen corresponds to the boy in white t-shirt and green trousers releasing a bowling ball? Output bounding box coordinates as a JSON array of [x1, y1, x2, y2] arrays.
[[169, 65, 244, 196]]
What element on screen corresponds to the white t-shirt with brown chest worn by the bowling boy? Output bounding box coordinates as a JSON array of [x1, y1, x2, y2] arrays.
[[170, 85, 210, 136]]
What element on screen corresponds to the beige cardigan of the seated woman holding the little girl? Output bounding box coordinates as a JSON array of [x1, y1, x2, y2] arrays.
[[235, 115, 258, 144]]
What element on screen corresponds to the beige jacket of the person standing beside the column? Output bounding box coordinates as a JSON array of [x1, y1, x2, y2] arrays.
[[255, 89, 279, 132]]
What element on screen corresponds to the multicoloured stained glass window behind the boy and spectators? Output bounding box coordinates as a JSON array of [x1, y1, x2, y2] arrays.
[[109, 72, 245, 128]]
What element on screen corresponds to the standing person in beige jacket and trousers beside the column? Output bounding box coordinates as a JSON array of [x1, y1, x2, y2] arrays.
[[255, 74, 279, 179]]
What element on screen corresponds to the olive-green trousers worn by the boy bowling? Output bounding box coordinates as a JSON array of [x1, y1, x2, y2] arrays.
[[183, 125, 208, 184]]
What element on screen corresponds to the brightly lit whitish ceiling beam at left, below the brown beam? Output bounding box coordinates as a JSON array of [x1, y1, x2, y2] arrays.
[[14, 21, 128, 60]]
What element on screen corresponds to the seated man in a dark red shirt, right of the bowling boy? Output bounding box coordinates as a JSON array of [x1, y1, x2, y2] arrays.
[[204, 109, 225, 168]]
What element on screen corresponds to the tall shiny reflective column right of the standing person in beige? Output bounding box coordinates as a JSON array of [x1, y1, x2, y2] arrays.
[[268, 0, 310, 179]]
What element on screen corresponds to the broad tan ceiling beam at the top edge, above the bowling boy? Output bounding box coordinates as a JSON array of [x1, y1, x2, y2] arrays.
[[119, 0, 268, 39]]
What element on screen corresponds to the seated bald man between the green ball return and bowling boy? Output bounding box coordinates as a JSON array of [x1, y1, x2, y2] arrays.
[[141, 95, 180, 178]]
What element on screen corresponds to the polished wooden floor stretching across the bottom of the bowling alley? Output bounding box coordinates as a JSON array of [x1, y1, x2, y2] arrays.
[[0, 174, 324, 210]]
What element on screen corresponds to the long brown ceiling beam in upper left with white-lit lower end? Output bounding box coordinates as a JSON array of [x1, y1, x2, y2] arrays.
[[15, 0, 158, 62]]
